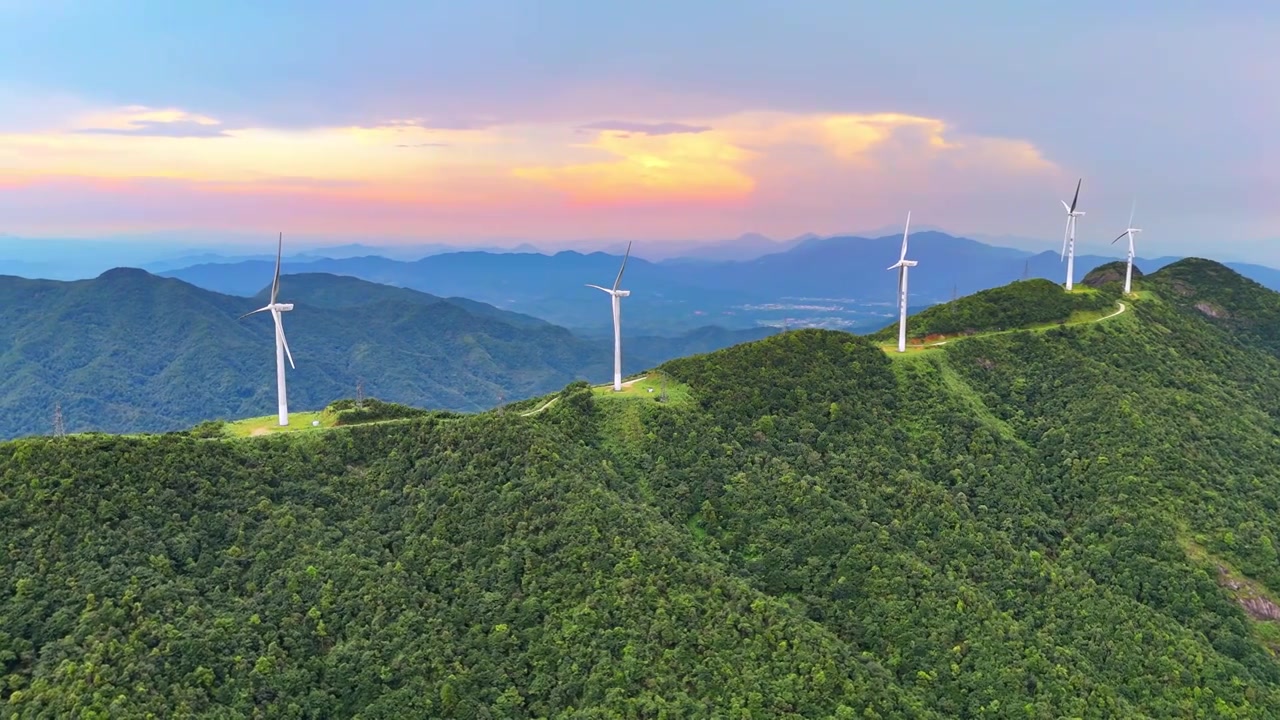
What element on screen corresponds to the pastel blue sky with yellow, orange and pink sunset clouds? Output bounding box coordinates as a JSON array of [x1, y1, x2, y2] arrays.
[[0, 0, 1280, 263]]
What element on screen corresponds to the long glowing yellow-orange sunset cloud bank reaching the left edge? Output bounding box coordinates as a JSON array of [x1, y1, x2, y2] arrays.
[[0, 101, 1059, 234]]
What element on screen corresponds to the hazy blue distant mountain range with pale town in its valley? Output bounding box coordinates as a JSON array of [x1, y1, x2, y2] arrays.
[[152, 231, 1280, 334]]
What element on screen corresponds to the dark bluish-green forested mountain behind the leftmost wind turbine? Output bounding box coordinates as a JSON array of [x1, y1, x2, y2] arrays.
[[0, 268, 769, 437]]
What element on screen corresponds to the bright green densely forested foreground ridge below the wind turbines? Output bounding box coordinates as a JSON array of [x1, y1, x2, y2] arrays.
[[0, 260, 1280, 720]]
